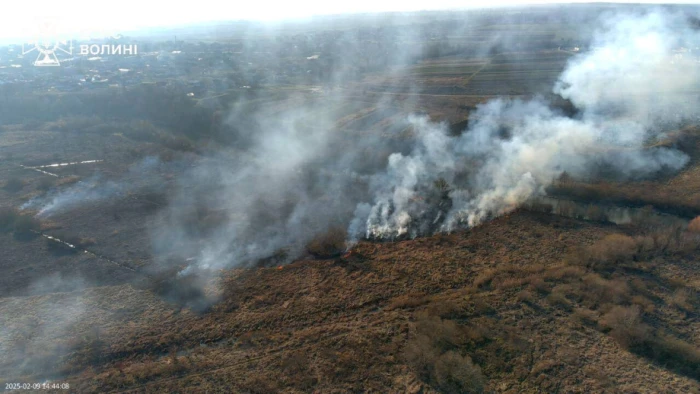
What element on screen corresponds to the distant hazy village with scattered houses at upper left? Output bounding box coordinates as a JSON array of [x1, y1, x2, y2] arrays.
[[0, 28, 412, 98]]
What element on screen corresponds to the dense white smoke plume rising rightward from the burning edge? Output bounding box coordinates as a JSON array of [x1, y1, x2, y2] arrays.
[[358, 12, 700, 238]]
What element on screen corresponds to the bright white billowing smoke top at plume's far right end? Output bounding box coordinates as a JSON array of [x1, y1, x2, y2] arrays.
[[554, 12, 700, 124]]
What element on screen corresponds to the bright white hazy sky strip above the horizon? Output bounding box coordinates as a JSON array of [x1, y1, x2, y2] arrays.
[[0, 0, 687, 40]]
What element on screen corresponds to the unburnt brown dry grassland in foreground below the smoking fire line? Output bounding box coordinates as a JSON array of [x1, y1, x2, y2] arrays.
[[0, 212, 698, 392]]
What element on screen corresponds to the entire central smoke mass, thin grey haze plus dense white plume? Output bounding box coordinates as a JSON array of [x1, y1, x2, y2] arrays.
[[154, 10, 700, 274]]
